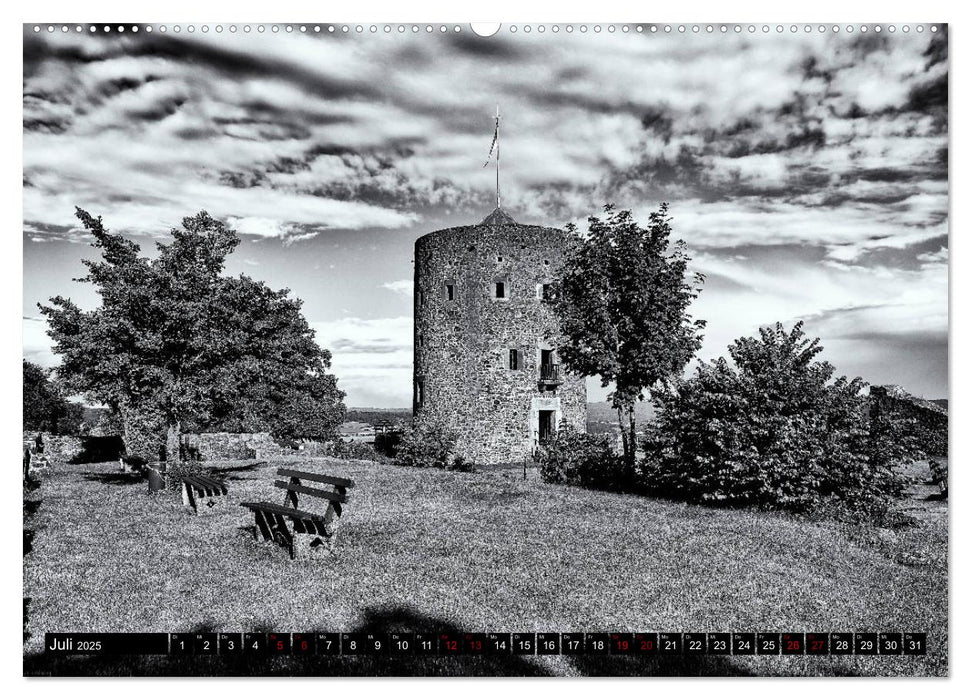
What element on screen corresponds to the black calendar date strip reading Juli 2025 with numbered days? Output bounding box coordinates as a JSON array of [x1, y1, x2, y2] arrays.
[[44, 632, 927, 656]]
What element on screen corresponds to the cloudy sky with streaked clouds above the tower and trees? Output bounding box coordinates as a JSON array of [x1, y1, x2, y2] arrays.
[[23, 25, 948, 406]]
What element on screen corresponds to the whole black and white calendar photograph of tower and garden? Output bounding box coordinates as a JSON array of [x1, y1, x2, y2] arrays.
[[22, 20, 950, 677]]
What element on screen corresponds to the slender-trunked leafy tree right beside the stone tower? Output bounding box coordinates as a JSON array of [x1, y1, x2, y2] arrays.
[[552, 204, 705, 470]]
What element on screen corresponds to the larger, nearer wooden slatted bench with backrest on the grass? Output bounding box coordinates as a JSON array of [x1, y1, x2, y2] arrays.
[[240, 468, 354, 559]]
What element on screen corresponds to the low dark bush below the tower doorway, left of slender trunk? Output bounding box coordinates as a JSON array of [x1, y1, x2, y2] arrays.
[[538, 425, 636, 491]]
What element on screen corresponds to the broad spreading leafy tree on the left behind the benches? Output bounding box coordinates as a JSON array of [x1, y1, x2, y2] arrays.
[[38, 209, 344, 461]]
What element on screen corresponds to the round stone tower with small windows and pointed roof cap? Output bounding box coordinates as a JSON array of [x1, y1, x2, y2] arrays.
[[414, 208, 587, 464]]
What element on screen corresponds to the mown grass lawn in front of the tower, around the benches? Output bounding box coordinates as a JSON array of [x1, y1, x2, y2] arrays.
[[24, 459, 947, 675]]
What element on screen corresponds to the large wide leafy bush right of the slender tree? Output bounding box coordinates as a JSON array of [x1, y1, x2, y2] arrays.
[[642, 323, 916, 513]]
